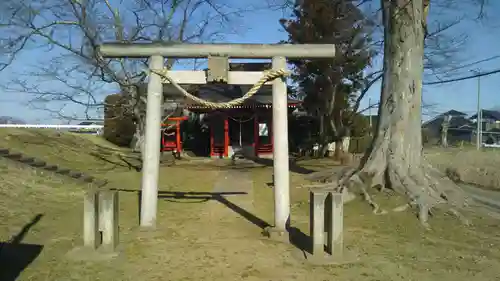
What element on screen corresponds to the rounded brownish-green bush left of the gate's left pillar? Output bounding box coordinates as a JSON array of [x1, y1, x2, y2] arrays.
[[104, 94, 135, 146]]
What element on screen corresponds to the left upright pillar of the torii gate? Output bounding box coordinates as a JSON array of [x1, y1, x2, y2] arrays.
[[141, 56, 163, 227]]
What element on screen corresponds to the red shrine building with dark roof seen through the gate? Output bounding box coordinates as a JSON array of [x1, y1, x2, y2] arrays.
[[161, 84, 300, 158]]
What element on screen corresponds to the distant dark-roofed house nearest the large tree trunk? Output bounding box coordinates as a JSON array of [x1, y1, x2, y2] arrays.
[[422, 110, 475, 143]]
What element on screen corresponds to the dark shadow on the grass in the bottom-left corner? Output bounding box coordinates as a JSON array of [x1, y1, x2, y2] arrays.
[[0, 214, 43, 281]]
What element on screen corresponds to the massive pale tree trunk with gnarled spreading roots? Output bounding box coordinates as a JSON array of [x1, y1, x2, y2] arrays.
[[341, 0, 465, 226]]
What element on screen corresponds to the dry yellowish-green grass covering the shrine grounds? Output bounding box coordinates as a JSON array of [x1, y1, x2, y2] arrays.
[[0, 130, 500, 281]]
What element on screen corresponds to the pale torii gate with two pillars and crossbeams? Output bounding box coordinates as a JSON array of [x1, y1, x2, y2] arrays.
[[98, 43, 335, 236]]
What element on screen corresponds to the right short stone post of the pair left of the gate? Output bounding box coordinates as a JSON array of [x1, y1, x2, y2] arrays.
[[100, 190, 119, 251]]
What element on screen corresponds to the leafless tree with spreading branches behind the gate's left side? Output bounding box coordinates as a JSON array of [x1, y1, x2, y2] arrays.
[[0, 0, 255, 152]]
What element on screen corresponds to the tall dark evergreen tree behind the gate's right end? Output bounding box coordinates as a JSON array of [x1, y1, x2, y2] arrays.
[[280, 0, 374, 142]]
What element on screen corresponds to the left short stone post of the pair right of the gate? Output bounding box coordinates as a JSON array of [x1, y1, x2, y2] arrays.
[[309, 190, 328, 257]]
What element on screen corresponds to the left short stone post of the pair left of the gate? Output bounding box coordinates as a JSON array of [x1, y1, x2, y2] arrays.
[[83, 190, 101, 250]]
